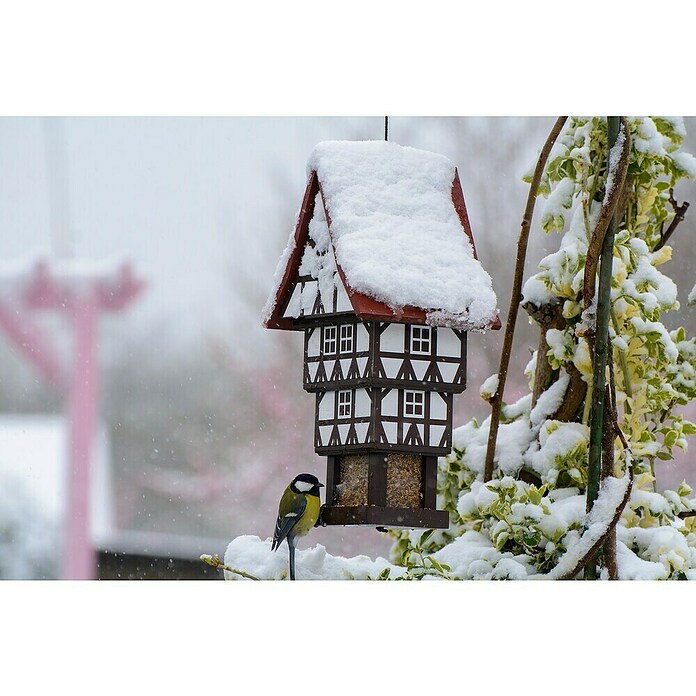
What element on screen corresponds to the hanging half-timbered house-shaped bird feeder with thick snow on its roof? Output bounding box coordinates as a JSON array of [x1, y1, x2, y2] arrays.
[[264, 141, 500, 528]]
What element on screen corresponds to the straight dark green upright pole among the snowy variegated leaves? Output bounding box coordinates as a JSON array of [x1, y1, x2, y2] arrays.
[[585, 116, 619, 578]]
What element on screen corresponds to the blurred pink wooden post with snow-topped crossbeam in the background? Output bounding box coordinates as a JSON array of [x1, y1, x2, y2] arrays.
[[0, 259, 143, 580]]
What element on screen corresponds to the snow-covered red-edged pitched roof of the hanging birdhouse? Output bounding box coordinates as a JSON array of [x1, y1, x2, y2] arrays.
[[264, 141, 498, 329]]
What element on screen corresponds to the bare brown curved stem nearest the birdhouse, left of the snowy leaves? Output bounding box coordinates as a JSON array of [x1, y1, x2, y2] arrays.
[[483, 116, 568, 481]]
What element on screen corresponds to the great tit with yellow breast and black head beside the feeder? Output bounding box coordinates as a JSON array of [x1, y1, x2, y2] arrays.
[[271, 474, 324, 580]]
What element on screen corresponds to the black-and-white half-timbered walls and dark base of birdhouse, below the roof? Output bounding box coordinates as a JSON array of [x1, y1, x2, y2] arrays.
[[294, 280, 460, 528]]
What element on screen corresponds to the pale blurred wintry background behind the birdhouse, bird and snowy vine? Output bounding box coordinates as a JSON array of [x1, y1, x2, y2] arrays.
[[0, 116, 696, 579]]
